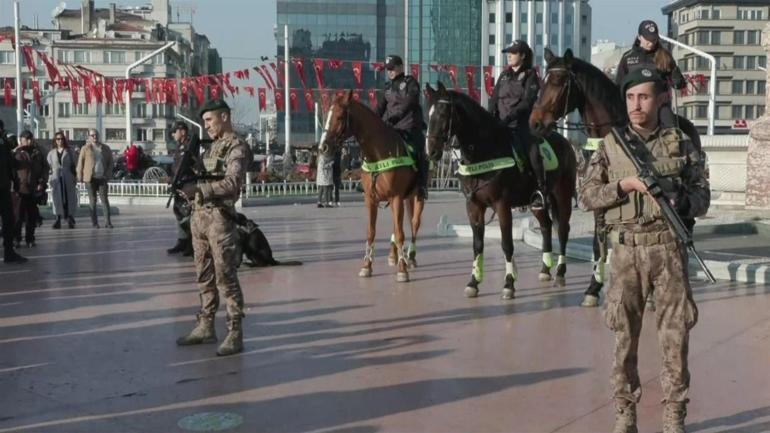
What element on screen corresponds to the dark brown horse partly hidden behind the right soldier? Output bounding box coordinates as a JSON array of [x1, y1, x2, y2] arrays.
[[530, 48, 701, 306]]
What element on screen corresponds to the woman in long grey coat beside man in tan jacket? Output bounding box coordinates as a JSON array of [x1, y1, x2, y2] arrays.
[[47, 131, 78, 229]]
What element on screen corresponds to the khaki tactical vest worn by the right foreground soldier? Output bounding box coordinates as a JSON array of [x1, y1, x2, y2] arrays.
[[604, 128, 686, 225]]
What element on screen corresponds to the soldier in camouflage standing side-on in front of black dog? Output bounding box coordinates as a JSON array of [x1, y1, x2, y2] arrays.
[[177, 100, 252, 356]]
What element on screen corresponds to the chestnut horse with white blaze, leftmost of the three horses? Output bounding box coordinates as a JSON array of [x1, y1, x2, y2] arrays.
[[319, 91, 425, 282]]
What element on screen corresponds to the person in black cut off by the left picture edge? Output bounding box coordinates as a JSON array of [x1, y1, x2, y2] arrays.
[[0, 120, 27, 263]]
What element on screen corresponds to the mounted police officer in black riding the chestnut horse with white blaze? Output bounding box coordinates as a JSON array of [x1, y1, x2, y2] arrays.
[[378, 55, 428, 200]]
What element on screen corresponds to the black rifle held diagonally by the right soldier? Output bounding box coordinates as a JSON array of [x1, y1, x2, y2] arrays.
[[612, 128, 717, 283]]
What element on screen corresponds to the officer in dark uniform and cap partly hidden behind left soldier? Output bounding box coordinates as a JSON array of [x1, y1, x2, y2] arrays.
[[166, 120, 200, 257]]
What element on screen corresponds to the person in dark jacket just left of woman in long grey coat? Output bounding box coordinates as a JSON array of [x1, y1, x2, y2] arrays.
[[13, 130, 49, 248]]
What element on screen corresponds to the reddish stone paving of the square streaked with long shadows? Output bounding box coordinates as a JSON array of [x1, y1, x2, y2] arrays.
[[0, 194, 770, 433]]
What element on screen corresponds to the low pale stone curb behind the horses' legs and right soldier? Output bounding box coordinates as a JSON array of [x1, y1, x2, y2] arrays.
[[437, 215, 770, 284]]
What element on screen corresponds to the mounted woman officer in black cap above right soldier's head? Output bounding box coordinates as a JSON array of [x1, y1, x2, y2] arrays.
[[615, 20, 687, 128]]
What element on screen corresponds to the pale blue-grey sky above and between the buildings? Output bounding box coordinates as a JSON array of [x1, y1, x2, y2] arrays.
[[0, 0, 670, 118]]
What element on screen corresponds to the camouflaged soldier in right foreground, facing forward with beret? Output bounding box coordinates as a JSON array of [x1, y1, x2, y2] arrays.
[[580, 68, 710, 433]]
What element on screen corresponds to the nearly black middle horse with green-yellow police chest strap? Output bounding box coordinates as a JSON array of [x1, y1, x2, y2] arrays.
[[426, 83, 577, 299]]
